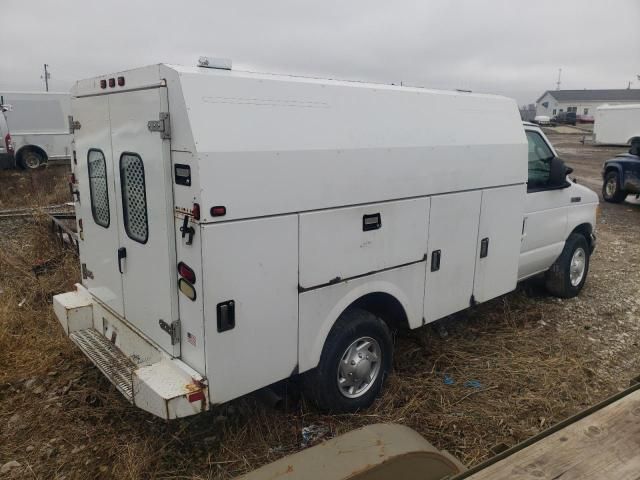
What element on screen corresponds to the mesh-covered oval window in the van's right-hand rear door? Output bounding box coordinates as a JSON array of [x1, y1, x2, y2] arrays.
[[120, 152, 149, 243]]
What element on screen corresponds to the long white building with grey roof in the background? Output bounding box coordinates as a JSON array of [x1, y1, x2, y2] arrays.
[[536, 89, 640, 118]]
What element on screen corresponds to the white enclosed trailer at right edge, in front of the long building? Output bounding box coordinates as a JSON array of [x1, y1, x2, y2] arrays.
[[593, 103, 640, 145]]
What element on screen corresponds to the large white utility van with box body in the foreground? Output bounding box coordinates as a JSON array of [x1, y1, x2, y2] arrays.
[[54, 59, 597, 418]]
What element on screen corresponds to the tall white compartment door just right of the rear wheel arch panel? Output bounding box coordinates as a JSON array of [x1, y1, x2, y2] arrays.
[[424, 191, 482, 322]]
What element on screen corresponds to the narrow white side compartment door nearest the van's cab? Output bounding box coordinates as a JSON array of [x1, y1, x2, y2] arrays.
[[473, 185, 526, 302]]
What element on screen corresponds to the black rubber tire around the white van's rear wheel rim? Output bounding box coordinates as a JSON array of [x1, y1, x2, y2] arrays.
[[303, 308, 393, 412]]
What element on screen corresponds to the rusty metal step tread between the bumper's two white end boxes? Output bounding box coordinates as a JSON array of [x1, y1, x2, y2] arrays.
[[69, 328, 136, 403]]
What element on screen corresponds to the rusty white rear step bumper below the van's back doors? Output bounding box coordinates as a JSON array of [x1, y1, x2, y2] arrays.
[[53, 285, 209, 419]]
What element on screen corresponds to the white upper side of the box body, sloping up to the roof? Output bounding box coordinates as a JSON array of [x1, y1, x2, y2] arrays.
[[172, 67, 527, 222]]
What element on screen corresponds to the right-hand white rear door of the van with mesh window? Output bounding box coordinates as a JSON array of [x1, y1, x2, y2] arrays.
[[108, 87, 180, 356]]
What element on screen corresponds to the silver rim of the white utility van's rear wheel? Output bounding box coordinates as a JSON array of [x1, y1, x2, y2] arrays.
[[337, 337, 382, 398]]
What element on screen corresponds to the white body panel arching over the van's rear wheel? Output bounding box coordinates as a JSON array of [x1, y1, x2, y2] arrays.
[[298, 262, 425, 372]]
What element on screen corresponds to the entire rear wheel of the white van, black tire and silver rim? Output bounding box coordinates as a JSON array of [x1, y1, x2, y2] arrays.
[[304, 308, 393, 412]]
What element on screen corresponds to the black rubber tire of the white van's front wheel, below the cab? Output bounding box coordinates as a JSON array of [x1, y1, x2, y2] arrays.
[[545, 233, 591, 298]]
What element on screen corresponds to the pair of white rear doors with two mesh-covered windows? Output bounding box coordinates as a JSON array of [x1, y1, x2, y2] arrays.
[[73, 87, 180, 356]]
